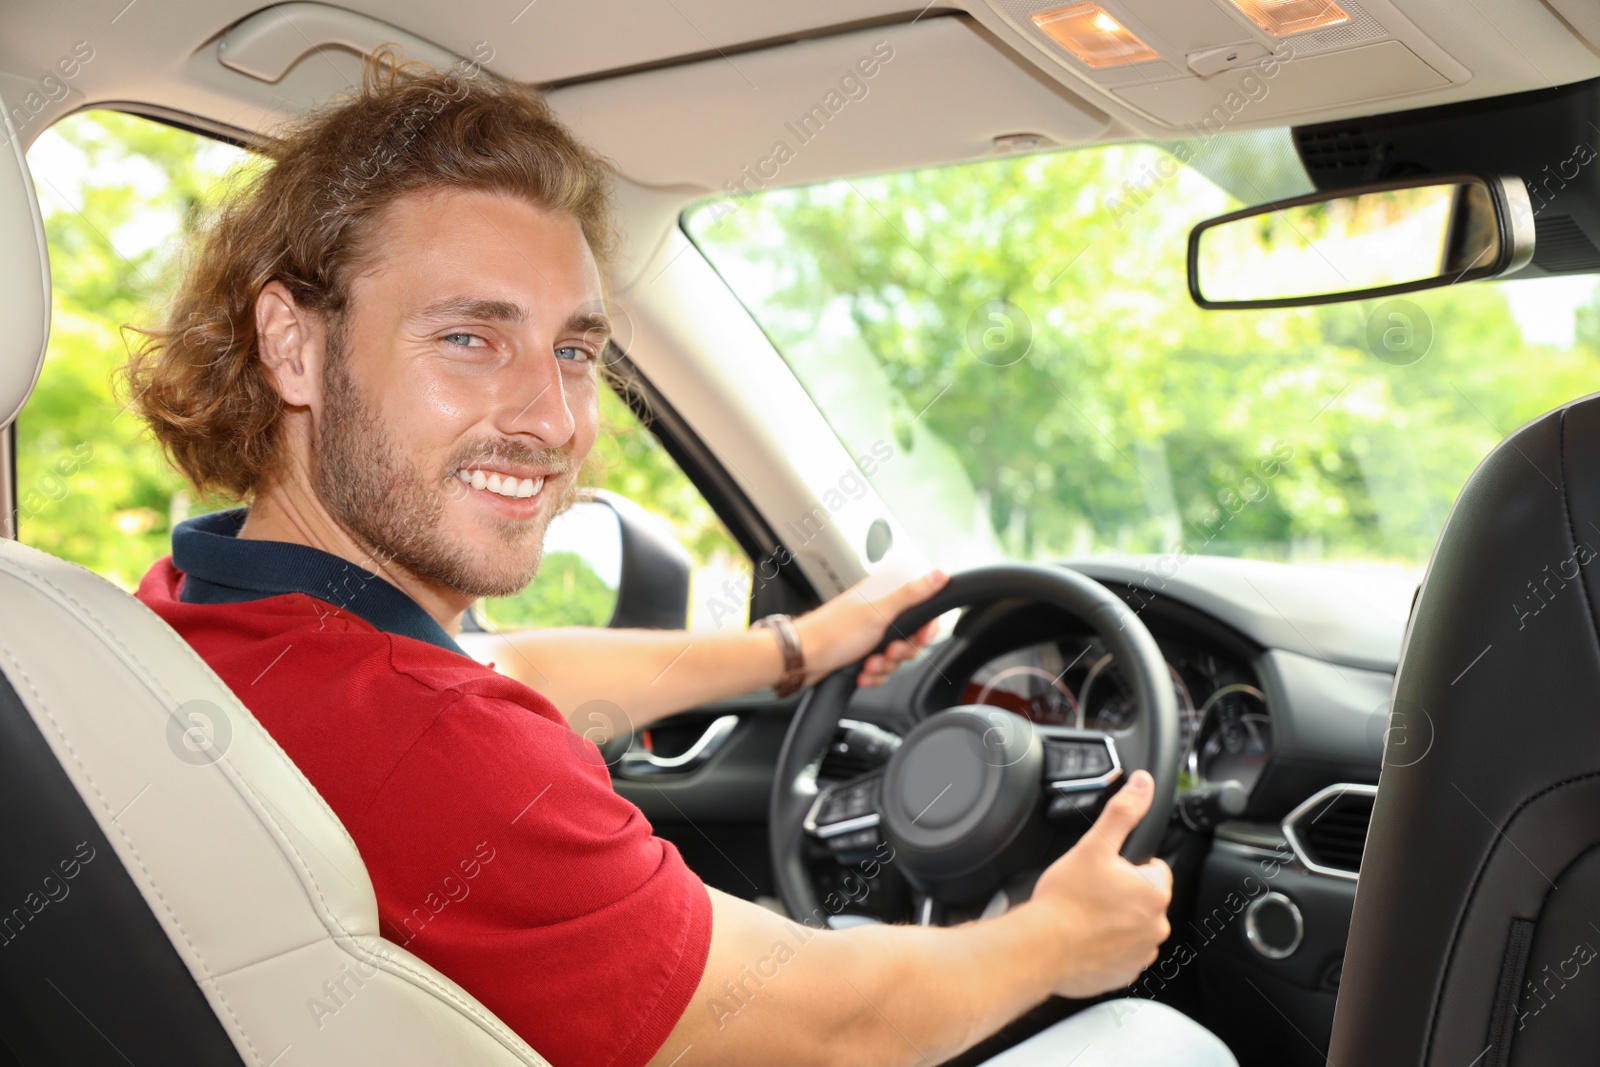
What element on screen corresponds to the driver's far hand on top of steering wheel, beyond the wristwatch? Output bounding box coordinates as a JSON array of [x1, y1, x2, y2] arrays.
[[795, 569, 949, 688]]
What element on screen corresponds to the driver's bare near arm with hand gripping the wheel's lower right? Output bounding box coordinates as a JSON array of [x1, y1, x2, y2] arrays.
[[650, 771, 1173, 1067]]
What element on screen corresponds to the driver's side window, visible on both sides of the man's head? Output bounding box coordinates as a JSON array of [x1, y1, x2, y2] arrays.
[[14, 110, 750, 629]]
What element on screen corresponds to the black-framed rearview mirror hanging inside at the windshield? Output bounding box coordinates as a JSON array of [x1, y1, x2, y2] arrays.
[[1189, 174, 1533, 309]]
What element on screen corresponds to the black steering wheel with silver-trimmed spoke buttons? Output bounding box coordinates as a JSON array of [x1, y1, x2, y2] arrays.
[[770, 563, 1182, 925]]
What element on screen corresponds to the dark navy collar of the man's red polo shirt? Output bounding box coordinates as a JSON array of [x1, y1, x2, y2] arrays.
[[173, 507, 466, 656]]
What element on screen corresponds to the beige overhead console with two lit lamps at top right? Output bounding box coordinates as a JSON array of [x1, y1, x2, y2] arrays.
[[971, 0, 1600, 136]]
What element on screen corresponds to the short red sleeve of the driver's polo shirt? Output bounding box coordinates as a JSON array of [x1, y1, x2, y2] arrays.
[[352, 696, 710, 1067]]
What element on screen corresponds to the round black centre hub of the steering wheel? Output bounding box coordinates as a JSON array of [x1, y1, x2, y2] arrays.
[[882, 705, 1045, 897]]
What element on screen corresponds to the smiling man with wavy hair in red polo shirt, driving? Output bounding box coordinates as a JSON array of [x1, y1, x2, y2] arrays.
[[128, 54, 1232, 1067]]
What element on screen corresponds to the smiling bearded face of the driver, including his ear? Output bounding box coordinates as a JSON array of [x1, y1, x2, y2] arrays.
[[262, 189, 610, 603]]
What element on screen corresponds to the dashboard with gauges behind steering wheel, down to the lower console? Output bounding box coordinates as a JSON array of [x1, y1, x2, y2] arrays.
[[813, 555, 1414, 1064]]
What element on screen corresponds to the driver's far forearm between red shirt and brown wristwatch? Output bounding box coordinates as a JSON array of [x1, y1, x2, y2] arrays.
[[494, 627, 782, 729]]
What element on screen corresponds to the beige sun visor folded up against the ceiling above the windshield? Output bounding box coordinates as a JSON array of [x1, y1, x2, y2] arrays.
[[549, 16, 1107, 192]]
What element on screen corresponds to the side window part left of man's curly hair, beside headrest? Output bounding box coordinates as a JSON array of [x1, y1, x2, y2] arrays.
[[16, 110, 250, 589]]
